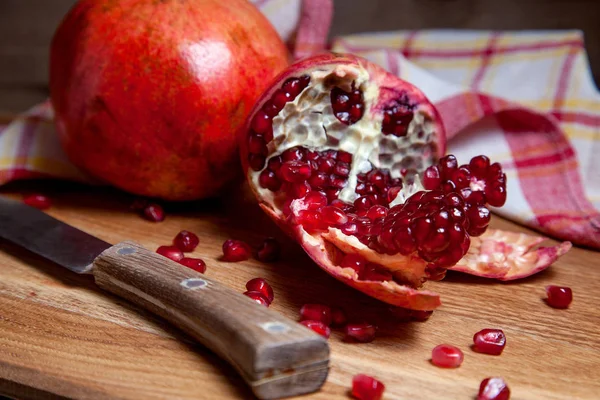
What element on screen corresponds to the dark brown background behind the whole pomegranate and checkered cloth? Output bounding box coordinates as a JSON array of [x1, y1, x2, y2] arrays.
[[0, 0, 600, 117]]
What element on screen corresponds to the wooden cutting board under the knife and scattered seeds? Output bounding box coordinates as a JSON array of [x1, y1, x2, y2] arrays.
[[0, 183, 600, 400]]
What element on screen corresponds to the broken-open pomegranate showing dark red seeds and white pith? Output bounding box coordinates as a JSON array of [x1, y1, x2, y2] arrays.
[[240, 54, 572, 310]]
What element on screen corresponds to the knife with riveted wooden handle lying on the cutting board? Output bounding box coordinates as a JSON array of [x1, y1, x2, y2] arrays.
[[0, 196, 329, 399]]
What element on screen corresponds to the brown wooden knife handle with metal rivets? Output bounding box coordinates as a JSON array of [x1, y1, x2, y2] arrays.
[[92, 242, 329, 399]]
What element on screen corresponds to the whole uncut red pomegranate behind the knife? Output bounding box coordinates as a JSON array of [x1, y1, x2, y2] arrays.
[[50, 0, 288, 200]]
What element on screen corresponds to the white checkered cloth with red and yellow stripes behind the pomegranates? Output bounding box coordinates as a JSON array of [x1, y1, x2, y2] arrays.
[[0, 0, 600, 249]]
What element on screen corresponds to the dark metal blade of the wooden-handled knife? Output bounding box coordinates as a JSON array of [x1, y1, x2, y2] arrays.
[[0, 196, 112, 274]]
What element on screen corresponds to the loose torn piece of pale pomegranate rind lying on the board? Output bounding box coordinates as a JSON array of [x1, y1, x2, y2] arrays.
[[449, 229, 572, 281]]
